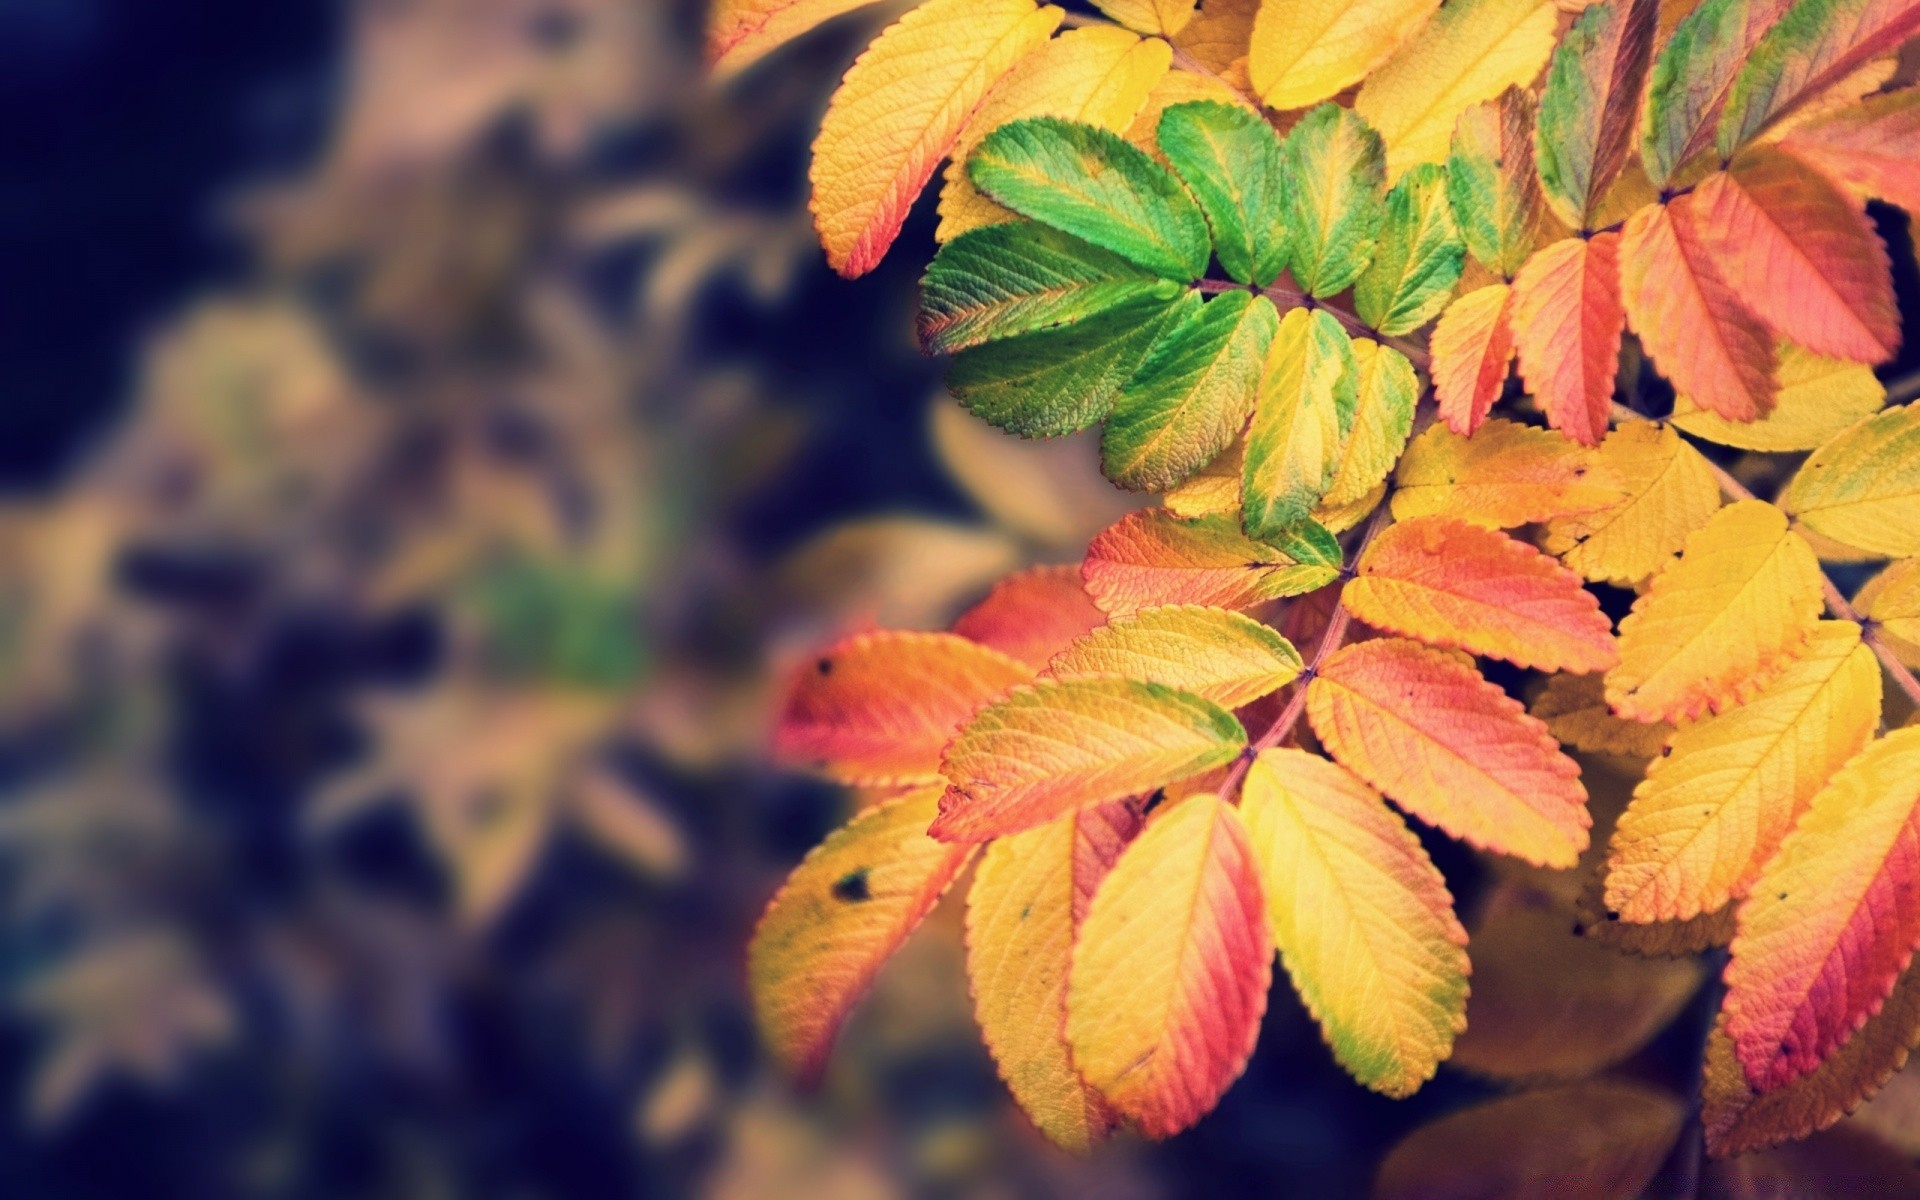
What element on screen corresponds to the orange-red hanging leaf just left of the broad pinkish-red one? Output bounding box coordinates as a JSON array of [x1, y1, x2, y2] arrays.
[[1620, 196, 1778, 420]]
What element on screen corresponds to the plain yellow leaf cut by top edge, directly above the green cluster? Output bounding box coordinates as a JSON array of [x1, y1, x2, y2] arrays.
[[1248, 0, 1438, 109]]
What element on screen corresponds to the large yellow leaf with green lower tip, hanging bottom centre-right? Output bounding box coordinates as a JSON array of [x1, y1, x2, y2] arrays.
[[1240, 749, 1469, 1096]]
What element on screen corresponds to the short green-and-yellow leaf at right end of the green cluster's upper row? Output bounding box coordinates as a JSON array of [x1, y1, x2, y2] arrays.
[[1354, 163, 1467, 334]]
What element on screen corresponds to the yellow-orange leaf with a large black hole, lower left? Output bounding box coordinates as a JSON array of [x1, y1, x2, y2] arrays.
[[747, 787, 973, 1081]]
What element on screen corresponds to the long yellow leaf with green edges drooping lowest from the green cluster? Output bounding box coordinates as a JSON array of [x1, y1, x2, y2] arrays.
[[1240, 309, 1357, 540]]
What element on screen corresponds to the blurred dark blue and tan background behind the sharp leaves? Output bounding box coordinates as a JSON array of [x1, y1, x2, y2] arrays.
[[0, 0, 1912, 1200]]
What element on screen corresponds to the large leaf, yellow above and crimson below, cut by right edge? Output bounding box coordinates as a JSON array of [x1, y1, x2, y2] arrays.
[[1726, 728, 1920, 1092]]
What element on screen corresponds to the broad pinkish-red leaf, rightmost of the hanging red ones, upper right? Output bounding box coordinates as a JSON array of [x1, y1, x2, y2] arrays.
[[1676, 148, 1901, 360]]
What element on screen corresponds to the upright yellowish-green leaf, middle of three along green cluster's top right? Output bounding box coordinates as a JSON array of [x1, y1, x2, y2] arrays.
[[1281, 104, 1386, 296]]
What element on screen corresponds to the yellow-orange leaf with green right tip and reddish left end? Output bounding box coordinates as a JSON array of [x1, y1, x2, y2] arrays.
[[929, 680, 1246, 841]]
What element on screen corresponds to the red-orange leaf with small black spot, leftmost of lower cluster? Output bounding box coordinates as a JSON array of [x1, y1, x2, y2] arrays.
[[774, 630, 1033, 787]]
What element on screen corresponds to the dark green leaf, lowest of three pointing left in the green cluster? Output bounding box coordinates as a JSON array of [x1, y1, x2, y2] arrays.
[[947, 290, 1200, 438]]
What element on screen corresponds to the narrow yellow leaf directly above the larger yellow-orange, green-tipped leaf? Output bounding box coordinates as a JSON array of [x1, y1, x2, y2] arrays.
[[1046, 605, 1302, 708]]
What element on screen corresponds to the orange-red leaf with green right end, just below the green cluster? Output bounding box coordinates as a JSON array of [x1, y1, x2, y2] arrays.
[[1083, 509, 1340, 616]]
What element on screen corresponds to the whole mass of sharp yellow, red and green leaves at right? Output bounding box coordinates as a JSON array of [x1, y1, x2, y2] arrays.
[[712, 0, 1920, 1194]]
